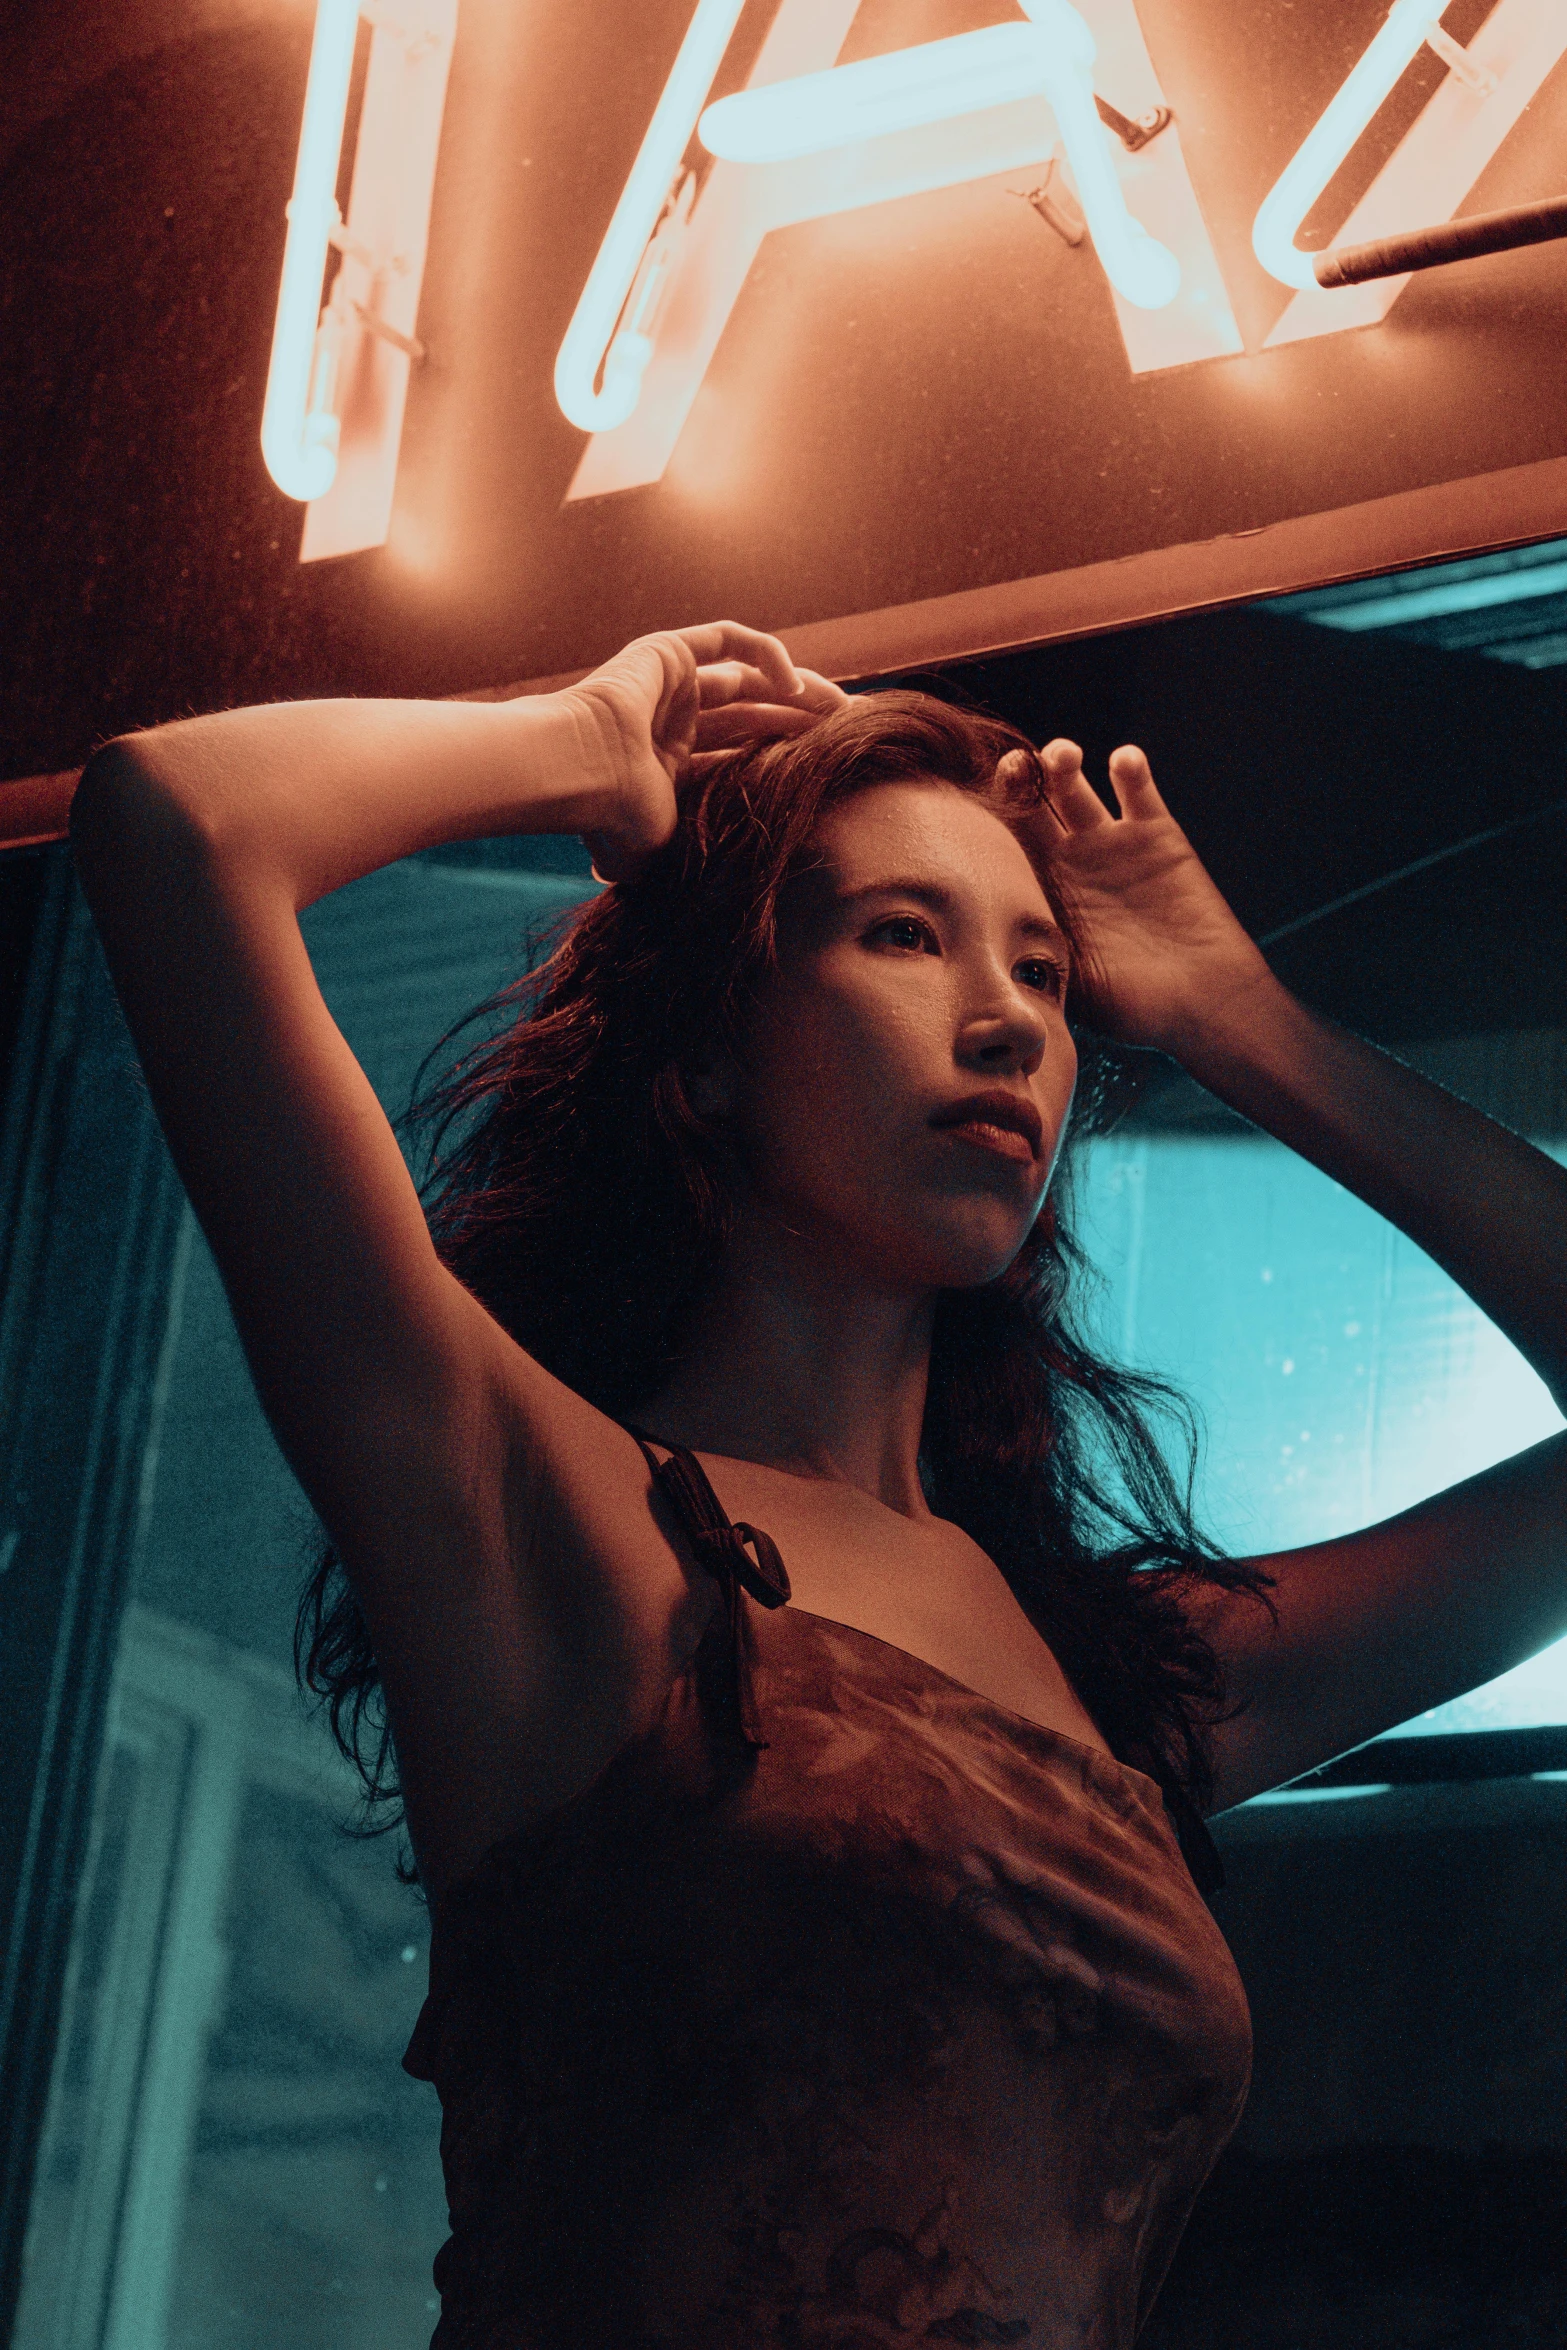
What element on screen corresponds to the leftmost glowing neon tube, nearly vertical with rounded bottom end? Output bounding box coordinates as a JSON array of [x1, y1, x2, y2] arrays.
[[261, 0, 359, 501]]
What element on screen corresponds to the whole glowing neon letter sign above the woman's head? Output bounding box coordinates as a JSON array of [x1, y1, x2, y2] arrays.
[[261, 0, 1567, 559]]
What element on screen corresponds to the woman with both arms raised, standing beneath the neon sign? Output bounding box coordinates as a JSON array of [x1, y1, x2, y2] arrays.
[[73, 623, 1567, 2350]]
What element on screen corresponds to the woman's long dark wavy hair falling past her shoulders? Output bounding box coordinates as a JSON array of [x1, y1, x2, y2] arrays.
[[296, 691, 1269, 1861]]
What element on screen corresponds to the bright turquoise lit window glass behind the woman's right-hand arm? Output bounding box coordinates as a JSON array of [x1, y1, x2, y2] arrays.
[[1081, 1133, 1567, 1737]]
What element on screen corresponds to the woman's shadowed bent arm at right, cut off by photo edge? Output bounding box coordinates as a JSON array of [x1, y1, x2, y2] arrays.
[[1029, 743, 1567, 1802]]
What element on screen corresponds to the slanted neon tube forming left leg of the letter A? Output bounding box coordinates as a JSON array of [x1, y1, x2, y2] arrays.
[[554, 0, 745, 432]]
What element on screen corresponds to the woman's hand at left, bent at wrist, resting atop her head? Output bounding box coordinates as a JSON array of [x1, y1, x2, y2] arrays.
[[561, 620, 848, 881]]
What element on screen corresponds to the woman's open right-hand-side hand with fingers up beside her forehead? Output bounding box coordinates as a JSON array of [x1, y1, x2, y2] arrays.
[[1031, 738, 1276, 1060]]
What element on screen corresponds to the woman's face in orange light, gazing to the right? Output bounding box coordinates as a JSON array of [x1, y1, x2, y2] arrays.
[[738, 783, 1076, 1293]]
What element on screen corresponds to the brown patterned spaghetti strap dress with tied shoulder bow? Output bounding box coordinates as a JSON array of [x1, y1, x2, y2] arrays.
[[404, 1438, 1252, 2350]]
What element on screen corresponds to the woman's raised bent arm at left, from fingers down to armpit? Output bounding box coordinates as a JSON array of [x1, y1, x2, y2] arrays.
[[73, 623, 836, 1857]]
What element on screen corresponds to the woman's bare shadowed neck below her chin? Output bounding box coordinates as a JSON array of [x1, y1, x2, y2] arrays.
[[637, 1231, 935, 1518]]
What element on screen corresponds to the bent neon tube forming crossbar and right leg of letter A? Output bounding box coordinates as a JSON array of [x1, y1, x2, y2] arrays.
[[698, 0, 1182, 310]]
